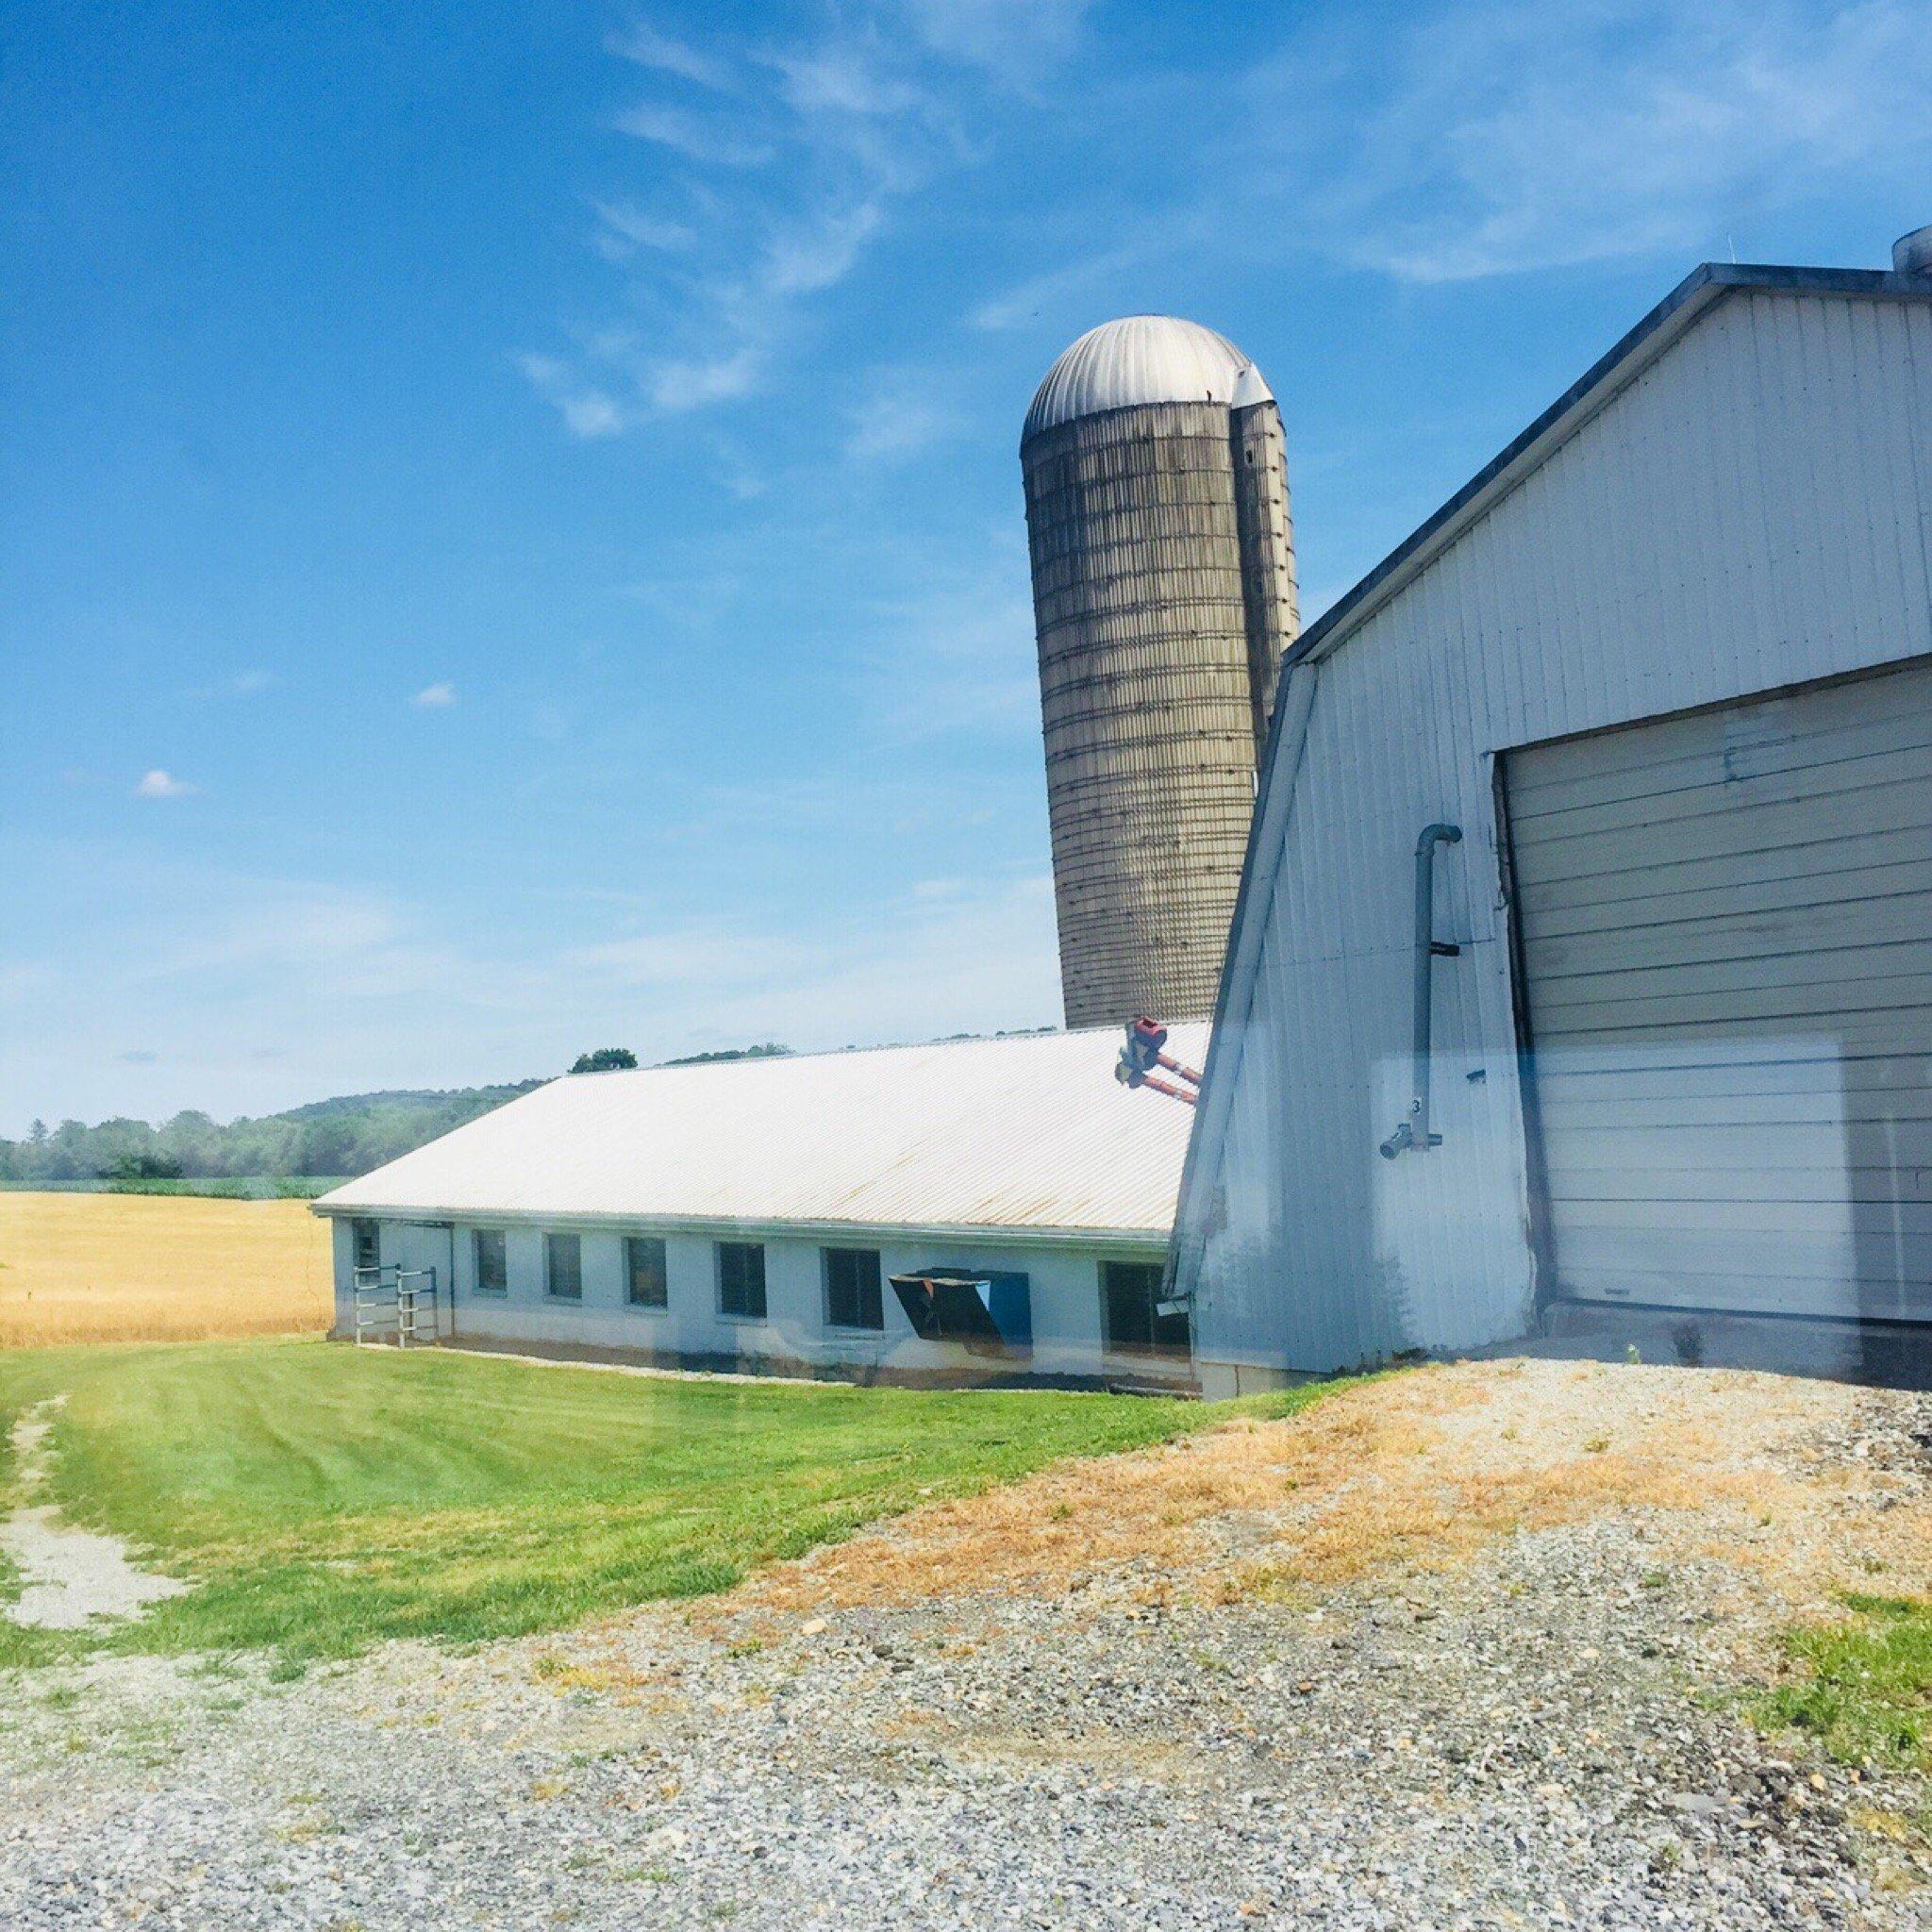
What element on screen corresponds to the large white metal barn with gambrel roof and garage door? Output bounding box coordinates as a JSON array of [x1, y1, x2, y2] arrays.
[[1173, 245, 1932, 1393]]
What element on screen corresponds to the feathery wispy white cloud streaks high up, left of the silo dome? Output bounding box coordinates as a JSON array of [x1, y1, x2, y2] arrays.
[[516, 0, 1084, 446]]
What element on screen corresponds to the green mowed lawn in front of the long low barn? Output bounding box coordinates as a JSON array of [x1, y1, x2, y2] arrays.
[[0, 1341, 1318, 1661]]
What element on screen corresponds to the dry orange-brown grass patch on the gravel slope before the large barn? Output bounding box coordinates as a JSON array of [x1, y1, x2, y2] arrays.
[[728, 1362, 1932, 1615]]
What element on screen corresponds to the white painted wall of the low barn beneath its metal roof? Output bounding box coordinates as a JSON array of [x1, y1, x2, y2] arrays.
[[334, 1219, 1158, 1379]]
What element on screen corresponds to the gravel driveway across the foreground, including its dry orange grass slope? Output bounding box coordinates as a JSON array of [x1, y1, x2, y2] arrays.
[[0, 1362, 1932, 1932]]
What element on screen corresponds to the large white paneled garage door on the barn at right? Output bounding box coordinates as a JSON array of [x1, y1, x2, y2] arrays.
[[1505, 658, 1932, 1320]]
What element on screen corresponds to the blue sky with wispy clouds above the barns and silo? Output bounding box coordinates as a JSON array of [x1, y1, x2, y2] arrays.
[[0, 0, 1932, 1132]]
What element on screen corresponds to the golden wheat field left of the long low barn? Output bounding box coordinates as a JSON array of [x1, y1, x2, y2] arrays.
[[0, 1194, 330, 1349]]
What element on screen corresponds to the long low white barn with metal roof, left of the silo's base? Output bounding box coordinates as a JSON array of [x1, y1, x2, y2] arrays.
[[315, 1025, 1208, 1383]]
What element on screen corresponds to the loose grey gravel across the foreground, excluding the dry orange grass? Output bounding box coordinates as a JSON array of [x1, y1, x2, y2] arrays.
[[0, 1364, 1932, 1932]]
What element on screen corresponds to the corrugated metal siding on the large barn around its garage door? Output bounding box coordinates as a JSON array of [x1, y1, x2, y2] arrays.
[[1176, 290, 1932, 1370]]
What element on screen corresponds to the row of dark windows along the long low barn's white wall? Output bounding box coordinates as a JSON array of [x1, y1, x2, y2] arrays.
[[356, 1221, 1189, 1353]]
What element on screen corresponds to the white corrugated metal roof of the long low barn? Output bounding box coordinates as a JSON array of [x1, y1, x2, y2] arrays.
[[317, 1024, 1208, 1241]]
